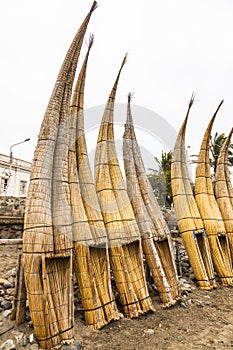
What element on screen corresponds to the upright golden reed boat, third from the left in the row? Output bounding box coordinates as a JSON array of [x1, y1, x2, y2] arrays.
[[95, 56, 154, 317]]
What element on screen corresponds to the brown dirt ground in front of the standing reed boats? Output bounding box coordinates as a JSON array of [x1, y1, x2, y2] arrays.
[[0, 247, 233, 350]]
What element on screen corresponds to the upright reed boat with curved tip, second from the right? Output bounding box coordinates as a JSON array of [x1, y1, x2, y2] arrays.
[[195, 101, 233, 285]]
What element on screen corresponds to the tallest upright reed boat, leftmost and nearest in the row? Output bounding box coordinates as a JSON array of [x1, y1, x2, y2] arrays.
[[23, 2, 97, 349]]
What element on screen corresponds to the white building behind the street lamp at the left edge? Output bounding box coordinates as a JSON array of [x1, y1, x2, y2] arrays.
[[0, 154, 31, 197]]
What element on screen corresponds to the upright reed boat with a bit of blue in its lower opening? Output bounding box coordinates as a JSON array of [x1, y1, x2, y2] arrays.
[[171, 96, 216, 290]]
